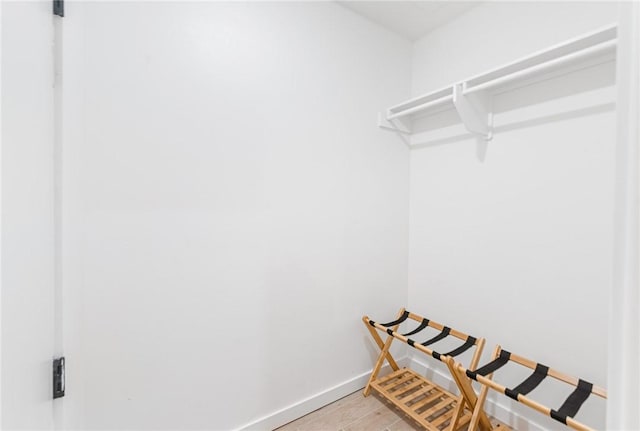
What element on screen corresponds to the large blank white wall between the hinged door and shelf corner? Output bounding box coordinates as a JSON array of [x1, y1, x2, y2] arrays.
[[63, 2, 411, 429]]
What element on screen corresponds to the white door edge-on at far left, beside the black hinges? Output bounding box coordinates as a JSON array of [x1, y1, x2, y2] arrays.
[[0, 1, 54, 430]]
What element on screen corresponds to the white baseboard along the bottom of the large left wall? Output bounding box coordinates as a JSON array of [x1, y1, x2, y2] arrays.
[[235, 356, 407, 431]]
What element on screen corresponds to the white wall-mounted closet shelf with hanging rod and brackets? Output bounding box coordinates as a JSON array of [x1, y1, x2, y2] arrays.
[[378, 25, 617, 140]]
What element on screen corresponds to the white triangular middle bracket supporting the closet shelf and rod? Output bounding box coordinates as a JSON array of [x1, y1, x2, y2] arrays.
[[453, 84, 493, 141]]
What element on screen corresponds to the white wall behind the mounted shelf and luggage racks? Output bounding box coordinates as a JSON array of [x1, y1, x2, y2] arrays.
[[409, 2, 617, 429]]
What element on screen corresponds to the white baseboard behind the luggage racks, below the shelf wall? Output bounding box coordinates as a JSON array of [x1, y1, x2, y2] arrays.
[[407, 358, 548, 431]]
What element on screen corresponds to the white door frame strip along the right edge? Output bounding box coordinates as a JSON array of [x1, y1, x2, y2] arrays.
[[607, 1, 640, 430]]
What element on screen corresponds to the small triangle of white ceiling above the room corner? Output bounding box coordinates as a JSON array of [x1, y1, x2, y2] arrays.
[[338, 0, 480, 41]]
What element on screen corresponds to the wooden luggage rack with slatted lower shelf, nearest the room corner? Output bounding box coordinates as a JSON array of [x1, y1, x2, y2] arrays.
[[362, 308, 491, 431]]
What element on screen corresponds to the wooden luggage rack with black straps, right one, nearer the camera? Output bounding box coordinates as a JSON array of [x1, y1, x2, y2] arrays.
[[444, 346, 607, 431]]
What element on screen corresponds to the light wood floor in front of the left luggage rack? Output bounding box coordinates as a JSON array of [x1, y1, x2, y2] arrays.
[[277, 390, 510, 431]]
